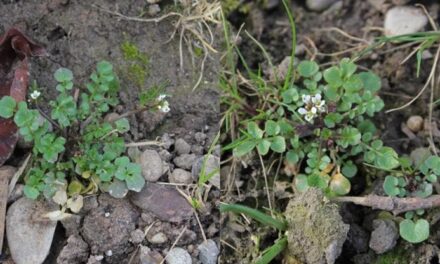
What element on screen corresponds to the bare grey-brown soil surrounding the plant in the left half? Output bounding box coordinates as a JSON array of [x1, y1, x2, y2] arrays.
[[0, 0, 221, 264]]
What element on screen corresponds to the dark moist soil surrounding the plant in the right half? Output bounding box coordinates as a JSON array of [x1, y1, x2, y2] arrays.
[[221, 0, 440, 264]]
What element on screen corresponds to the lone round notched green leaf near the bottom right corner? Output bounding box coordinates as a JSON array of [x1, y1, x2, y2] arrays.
[[399, 219, 429, 243]]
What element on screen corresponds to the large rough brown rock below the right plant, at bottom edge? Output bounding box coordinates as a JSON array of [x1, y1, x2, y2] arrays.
[[284, 188, 349, 264]]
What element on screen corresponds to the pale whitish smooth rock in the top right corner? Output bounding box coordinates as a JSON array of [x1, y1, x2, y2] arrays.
[[384, 6, 428, 36]]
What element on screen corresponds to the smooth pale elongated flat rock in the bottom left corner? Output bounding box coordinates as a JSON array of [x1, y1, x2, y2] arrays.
[[6, 197, 58, 264]]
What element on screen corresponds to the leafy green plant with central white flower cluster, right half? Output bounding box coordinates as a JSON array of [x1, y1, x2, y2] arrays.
[[228, 59, 392, 196]]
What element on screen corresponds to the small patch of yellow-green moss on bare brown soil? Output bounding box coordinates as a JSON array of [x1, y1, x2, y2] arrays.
[[121, 40, 150, 88]]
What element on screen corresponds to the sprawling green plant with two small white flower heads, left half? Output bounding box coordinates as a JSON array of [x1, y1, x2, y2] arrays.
[[0, 61, 169, 218]]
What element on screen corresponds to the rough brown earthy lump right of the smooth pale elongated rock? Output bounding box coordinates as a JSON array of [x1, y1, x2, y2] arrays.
[[81, 194, 139, 264]]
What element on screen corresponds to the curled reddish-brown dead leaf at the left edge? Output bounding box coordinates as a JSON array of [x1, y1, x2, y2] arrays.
[[0, 28, 46, 166]]
